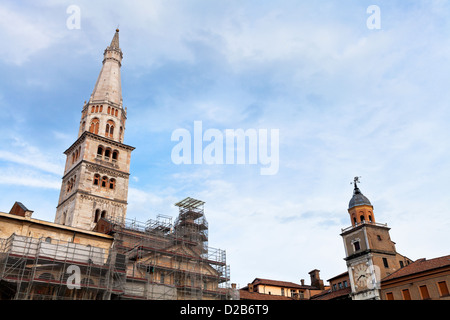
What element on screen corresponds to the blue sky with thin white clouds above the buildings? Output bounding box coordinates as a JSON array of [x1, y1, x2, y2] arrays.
[[0, 0, 450, 286]]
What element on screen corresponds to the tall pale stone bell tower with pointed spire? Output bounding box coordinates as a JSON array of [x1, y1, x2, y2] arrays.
[[55, 29, 134, 230]]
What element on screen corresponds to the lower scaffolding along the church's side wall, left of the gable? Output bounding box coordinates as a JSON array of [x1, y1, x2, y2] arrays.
[[0, 234, 125, 300]]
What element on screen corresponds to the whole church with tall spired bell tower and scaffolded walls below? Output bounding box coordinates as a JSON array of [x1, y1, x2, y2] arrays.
[[0, 29, 230, 300]]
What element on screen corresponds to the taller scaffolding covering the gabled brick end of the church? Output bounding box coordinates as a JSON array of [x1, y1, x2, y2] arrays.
[[109, 198, 230, 300]]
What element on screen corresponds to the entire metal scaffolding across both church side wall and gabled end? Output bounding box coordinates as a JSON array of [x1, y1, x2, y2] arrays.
[[0, 198, 230, 300]]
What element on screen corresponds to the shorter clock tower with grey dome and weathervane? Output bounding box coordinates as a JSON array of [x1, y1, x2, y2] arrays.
[[341, 177, 411, 300]]
